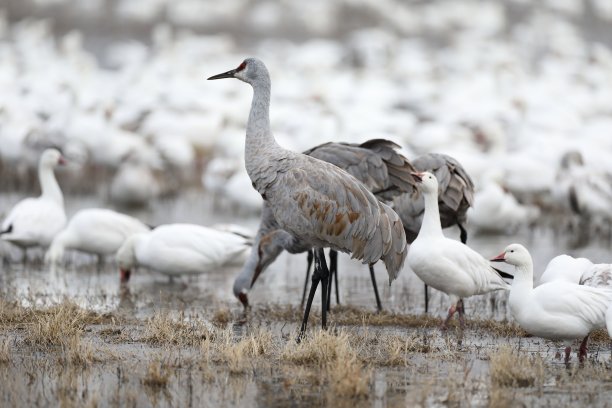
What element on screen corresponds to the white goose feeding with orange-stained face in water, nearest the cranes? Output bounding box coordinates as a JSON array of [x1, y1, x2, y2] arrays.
[[117, 224, 251, 282]]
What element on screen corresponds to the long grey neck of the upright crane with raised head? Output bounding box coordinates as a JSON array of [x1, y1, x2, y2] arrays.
[[245, 76, 281, 184]]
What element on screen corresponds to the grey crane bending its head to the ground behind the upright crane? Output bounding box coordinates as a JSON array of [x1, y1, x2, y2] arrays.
[[234, 139, 415, 310]]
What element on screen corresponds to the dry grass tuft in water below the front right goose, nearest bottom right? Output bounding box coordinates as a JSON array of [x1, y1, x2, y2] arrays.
[[490, 346, 544, 387]]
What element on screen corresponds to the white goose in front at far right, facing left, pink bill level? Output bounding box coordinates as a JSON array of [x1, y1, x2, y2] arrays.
[[491, 244, 612, 363]]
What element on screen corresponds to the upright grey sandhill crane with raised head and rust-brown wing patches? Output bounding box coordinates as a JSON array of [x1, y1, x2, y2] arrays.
[[208, 58, 407, 334]]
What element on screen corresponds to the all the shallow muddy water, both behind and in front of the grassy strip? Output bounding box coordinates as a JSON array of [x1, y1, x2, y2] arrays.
[[0, 191, 612, 407]]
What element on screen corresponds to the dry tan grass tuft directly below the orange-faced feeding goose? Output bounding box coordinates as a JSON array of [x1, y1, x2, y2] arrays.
[[140, 312, 214, 346]]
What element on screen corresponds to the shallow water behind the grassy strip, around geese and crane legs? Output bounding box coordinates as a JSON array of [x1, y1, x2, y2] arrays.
[[0, 191, 612, 320]]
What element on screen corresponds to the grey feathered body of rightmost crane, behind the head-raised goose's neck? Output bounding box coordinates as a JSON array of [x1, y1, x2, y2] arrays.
[[393, 153, 474, 242]]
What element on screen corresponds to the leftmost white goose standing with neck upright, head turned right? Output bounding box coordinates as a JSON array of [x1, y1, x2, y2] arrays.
[[0, 149, 66, 249]]
